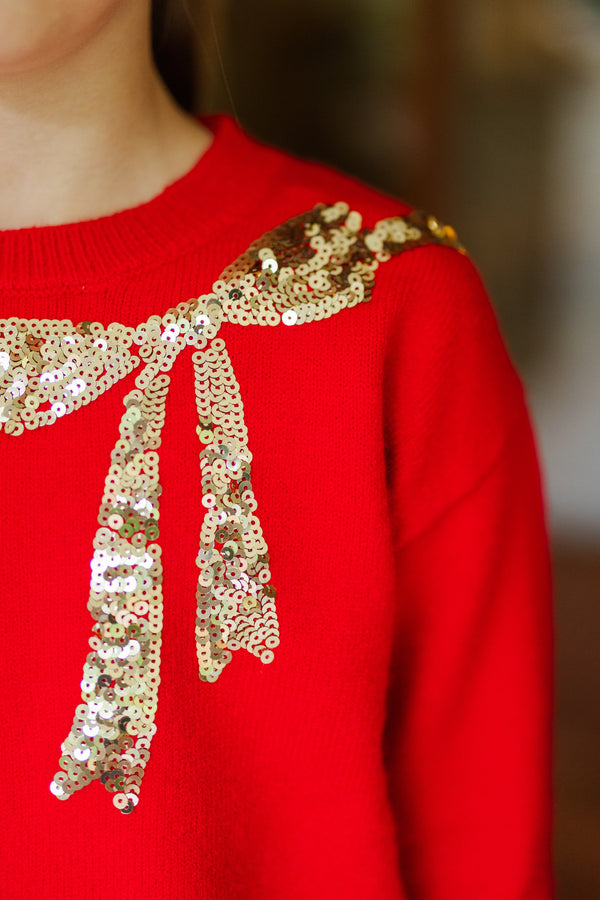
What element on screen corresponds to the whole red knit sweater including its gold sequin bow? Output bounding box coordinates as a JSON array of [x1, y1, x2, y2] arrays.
[[0, 117, 552, 900]]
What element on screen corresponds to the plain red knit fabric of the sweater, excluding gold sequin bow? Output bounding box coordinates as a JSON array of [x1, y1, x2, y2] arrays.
[[0, 115, 553, 900]]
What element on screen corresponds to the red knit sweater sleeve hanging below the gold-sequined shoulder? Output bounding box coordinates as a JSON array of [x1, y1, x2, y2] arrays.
[[384, 247, 553, 900]]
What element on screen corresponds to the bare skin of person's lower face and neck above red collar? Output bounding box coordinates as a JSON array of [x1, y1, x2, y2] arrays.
[[0, 0, 212, 229]]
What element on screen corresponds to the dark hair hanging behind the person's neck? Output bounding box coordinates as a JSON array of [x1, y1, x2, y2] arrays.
[[152, 0, 199, 112]]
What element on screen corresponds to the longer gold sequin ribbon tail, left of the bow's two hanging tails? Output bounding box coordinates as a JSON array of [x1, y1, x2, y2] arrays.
[[50, 371, 169, 813]]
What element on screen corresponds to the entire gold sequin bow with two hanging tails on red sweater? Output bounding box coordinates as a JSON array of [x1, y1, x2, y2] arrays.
[[0, 203, 462, 813]]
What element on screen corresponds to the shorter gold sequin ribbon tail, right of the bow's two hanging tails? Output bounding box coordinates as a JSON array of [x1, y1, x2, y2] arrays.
[[193, 339, 279, 681]]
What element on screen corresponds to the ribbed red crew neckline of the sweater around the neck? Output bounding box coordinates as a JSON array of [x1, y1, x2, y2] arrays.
[[0, 113, 272, 289]]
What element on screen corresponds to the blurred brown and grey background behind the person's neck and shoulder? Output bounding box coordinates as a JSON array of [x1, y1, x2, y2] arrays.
[[155, 0, 600, 900]]
